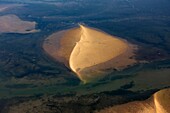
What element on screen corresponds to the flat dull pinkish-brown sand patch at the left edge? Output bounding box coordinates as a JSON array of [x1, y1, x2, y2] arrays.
[[0, 15, 39, 33]]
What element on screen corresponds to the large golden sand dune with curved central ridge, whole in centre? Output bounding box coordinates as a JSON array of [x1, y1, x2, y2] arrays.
[[43, 25, 136, 83]]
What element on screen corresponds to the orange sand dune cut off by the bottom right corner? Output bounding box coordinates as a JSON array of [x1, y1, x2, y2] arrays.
[[96, 88, 170, 113]]
